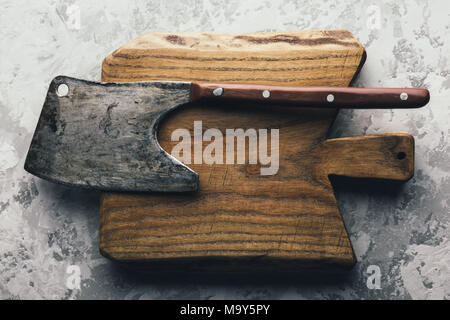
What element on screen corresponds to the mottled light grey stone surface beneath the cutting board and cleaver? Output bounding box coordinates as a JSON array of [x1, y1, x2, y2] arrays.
[[0, 0, 450, 299]]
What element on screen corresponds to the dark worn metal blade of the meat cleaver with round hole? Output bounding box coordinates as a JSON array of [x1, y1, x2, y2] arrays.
[[25, 76, 198, 192]]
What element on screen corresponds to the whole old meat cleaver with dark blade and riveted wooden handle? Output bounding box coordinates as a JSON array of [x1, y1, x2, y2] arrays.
[[25, 76, 429, 192]]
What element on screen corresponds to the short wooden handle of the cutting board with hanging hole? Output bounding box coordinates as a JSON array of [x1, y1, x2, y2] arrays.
[[317, 132, 414, 181]]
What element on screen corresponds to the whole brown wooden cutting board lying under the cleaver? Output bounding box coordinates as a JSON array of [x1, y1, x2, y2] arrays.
[[100, 30, 414, 272]]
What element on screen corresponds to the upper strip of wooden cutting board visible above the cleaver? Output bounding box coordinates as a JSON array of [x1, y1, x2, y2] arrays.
[[102, 30, 365, 86]]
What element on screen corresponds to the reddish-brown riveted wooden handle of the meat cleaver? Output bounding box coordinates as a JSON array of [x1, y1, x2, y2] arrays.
[[192, 83, 430, 109]]
